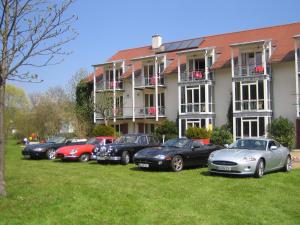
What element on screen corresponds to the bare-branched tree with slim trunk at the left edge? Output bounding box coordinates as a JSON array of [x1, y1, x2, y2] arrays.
[[0, 0, 77, 195]]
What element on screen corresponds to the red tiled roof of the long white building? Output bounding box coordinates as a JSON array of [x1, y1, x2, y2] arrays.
[[87, 23, 300, 81]]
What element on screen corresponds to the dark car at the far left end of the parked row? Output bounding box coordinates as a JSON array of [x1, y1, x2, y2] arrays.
[[22, 137, 86, 160]]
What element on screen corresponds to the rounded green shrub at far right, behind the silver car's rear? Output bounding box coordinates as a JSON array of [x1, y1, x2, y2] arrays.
[[268, 117, 295, 148]]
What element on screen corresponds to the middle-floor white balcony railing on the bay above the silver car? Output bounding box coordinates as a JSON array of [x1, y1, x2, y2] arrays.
[[235, 99, 271, 111]]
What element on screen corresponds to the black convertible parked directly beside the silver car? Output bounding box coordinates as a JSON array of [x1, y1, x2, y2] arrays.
[[133, 138, 221, 172]]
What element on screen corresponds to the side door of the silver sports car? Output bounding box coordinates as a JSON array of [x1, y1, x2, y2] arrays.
[[266, 140, 282, 170]]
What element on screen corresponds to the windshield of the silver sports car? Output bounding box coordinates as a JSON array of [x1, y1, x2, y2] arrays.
[[228, 139, 267, 150]]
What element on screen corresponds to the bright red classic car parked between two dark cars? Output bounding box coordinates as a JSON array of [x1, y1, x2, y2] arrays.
[[55, 136, 115, 162]]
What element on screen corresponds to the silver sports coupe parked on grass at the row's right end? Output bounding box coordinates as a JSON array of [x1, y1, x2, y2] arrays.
[[208, 138, 292, 178]]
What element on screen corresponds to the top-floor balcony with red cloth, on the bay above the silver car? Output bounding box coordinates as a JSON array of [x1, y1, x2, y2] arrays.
[[234, 65, 270, 77]]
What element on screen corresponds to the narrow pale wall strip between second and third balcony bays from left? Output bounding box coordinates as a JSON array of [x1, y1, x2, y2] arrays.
[[165, 74, 179, 122]]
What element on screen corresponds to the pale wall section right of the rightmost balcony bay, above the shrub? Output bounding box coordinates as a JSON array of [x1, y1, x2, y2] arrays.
[[272, 61, 297, 124]]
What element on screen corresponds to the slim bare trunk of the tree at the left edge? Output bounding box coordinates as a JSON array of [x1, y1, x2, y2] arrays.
[[0, 84, 6, 196]]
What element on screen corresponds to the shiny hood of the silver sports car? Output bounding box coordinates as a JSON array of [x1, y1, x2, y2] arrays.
[[211, 149, 265, 160]]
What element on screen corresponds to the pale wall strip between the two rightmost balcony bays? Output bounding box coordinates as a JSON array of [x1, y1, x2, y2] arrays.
[[215, 68, 232, 127]]
